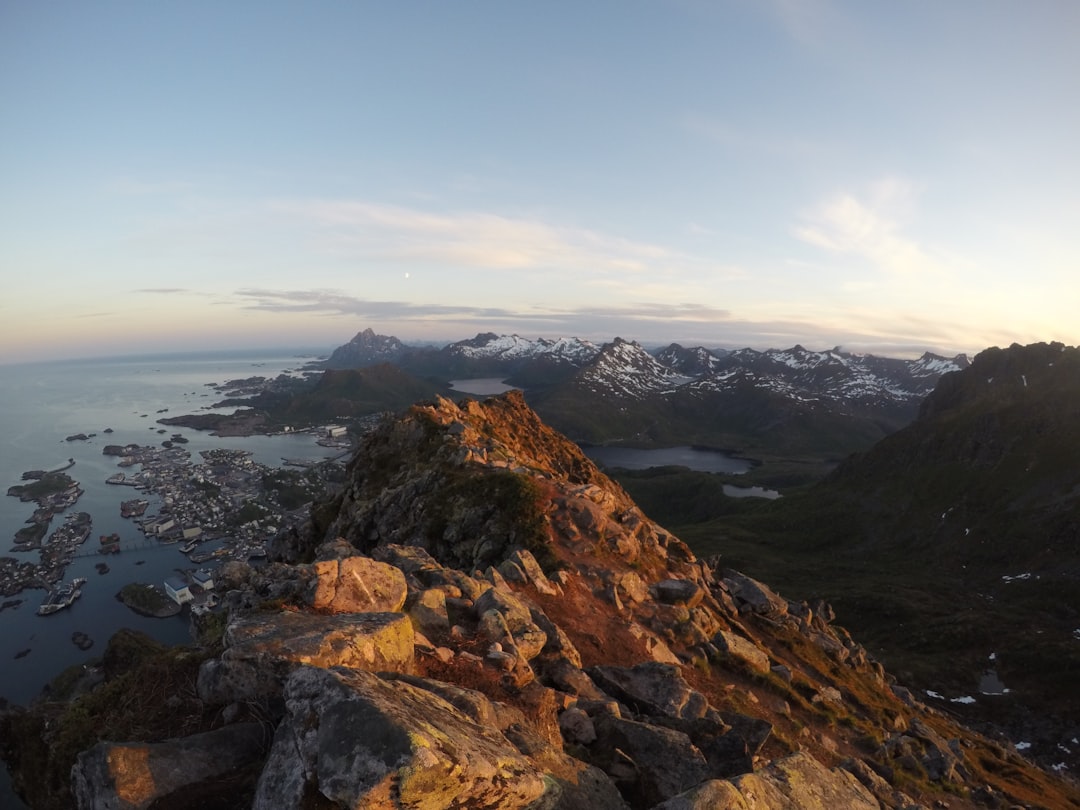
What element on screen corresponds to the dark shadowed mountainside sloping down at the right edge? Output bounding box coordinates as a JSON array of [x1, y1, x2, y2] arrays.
[[656, 343, 1080, 772]]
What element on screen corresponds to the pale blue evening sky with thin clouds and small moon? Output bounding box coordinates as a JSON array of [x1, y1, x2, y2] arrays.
[[0, 0, 1080, 363]]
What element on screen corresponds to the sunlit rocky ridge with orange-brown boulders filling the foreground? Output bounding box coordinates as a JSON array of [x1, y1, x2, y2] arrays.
[[0, 392, 1080, 810]]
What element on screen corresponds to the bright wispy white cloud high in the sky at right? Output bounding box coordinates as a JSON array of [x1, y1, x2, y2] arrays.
[[794, 179, 942, 275]]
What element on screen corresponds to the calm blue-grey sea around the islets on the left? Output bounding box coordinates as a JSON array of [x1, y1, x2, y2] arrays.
[[0, 350, 340, 808]]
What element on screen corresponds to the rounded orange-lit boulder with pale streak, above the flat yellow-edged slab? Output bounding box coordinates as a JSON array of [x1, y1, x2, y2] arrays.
[[311, 557, 408, 613]]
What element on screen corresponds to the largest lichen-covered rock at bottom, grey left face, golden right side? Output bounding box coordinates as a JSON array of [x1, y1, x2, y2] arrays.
[[253, 667, 545, 810]]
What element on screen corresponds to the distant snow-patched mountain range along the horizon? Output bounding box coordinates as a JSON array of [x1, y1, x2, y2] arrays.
[[320, 329, 969, 461]]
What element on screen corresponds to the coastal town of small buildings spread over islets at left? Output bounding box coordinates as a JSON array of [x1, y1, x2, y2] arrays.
[[0, 426, 351, 612]]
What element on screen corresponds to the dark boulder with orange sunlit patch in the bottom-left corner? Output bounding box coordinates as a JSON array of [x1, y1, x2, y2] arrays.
[[71, 723, 267, 810]]
